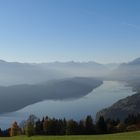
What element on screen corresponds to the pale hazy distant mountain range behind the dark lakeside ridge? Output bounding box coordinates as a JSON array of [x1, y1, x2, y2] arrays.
[[0, 60, 114, 86]]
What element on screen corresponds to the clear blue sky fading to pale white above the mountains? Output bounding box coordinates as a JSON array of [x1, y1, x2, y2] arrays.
[[0, 0, 140, 63]]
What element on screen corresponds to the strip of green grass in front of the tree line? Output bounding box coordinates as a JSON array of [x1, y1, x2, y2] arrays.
[[0, 131, 140, 140]]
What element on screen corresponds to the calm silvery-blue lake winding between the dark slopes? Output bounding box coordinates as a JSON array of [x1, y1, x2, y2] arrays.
[[0, 81, 135, 129]]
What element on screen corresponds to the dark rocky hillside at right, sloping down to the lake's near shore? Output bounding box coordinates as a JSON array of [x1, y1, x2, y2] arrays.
[[96, 93, 140, 120]]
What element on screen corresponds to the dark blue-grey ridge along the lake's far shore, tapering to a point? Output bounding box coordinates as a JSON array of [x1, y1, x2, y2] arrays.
[[0, 78, 102, 113]]
